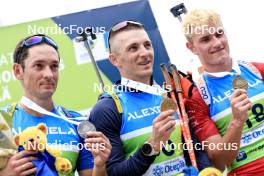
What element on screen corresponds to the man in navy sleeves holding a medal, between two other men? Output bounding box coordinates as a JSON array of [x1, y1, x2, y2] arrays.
[[90, 21, 210, 176]]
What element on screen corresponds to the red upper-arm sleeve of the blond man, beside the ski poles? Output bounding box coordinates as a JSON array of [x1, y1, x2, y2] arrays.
[[185, 87, 219, 141]]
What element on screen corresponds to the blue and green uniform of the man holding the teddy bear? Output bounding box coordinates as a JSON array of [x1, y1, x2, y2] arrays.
[[0, 105, 93, 176]]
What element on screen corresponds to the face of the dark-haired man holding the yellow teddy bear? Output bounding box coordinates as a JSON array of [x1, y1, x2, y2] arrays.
[[15, 44, 59, 100]]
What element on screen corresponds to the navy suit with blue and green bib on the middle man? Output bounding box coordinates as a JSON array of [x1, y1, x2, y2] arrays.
[[90, 83, 210, 175]]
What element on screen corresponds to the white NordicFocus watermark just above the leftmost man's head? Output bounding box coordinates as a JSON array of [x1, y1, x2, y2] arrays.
[[27, 24, 106, 35]]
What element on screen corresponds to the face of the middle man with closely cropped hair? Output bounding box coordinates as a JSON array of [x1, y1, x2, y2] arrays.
[[110, 29, 154, 81]]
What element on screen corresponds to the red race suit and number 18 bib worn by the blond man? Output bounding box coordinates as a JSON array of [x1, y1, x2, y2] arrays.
[[186, 62, 264, 176]]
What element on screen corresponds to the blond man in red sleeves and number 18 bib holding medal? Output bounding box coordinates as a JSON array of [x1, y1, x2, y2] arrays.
[[183, 9, 264, 176]]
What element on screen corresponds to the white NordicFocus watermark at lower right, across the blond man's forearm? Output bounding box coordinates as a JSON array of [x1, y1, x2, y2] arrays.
[[160, 140, 238, 151]]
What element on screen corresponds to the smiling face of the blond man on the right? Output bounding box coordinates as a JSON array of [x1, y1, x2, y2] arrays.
[[187, 25, 231, 72]]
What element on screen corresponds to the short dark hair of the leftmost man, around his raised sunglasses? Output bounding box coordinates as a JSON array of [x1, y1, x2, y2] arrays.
[[13, 34, 60, 69]]
